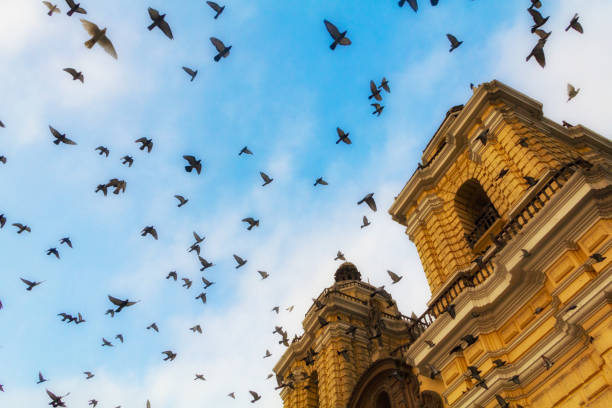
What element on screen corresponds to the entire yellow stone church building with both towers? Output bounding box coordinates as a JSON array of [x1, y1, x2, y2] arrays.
[[274, 81, 612, 408]]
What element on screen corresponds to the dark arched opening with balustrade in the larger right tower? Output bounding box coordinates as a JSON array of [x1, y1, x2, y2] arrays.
[[455, 179, 499, 248]]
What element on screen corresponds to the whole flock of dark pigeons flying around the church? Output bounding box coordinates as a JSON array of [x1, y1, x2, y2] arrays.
[[0, 0, 602, 408]]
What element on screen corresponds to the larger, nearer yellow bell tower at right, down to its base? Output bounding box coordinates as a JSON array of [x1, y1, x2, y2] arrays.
[[389, 81, 612, 407]]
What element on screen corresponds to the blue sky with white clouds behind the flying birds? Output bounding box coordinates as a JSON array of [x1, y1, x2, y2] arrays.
[[0, 0, 612, 408]]
